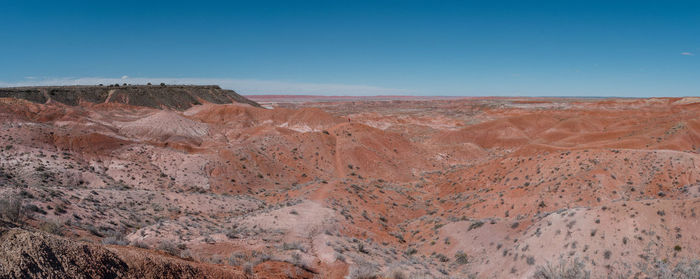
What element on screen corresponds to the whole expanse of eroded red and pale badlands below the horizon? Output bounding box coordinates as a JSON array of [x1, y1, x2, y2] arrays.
[[0, 93, 700, 278]]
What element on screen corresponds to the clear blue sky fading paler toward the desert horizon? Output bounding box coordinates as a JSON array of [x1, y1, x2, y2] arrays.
[[0, 0, 700, 96]]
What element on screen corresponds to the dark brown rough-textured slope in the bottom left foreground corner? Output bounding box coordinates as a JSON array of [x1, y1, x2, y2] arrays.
[[0, 228, 298, 278]]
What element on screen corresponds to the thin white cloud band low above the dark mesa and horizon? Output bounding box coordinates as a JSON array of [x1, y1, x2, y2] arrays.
[[0, 76, 410, 96]]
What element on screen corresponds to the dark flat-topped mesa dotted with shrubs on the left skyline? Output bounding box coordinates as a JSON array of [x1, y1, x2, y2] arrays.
[[0, 85, 260, 110]]
